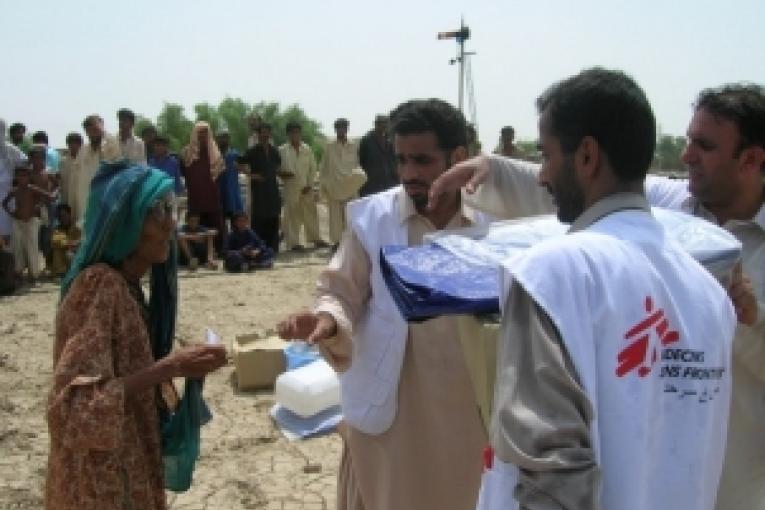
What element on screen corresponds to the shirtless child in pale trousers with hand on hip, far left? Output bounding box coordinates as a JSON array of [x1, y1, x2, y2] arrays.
[[2, 166, 54, 282]]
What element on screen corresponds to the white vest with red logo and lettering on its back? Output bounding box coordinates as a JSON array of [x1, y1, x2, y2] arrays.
[[480, 210, 736, 510]]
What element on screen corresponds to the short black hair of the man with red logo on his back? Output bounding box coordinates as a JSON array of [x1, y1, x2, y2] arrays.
[[537, 67, 656, 181]]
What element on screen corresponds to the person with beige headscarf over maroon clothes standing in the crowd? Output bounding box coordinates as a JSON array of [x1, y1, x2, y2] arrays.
[[181, 122, 225, 251]]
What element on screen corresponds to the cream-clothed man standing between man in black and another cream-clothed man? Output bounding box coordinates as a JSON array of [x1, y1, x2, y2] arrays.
[[279, 122, 328, 252]]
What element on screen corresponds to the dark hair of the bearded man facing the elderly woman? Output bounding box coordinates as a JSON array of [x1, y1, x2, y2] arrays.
[[390, 99, 467, 151]]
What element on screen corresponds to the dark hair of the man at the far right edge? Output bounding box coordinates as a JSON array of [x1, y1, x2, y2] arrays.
[[694, 83, 765, 153]]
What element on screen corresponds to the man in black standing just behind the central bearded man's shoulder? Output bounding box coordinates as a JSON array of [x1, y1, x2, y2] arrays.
[[359, 115, 398, 197]]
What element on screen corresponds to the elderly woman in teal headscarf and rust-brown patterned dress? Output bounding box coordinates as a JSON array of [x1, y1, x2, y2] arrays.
[[46, 163, 226, 510]]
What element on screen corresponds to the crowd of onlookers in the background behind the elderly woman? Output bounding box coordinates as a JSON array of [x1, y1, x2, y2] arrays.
[[0, 108, 412, 293]]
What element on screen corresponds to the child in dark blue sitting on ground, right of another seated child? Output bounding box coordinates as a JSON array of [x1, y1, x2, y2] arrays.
[[223, 212, 274, 272]]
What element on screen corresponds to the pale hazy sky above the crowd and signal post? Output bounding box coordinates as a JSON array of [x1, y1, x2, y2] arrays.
[[0, 0, 765, 149]]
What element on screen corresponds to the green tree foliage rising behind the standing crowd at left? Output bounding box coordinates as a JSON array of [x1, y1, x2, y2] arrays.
[[135, 97, 324, 157]]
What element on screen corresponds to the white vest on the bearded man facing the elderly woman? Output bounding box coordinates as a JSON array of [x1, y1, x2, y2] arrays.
[[340, 186, 409, 434]]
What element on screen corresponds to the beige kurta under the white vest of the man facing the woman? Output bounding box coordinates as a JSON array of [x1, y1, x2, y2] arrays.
[[316, 190, 487, 510]]
